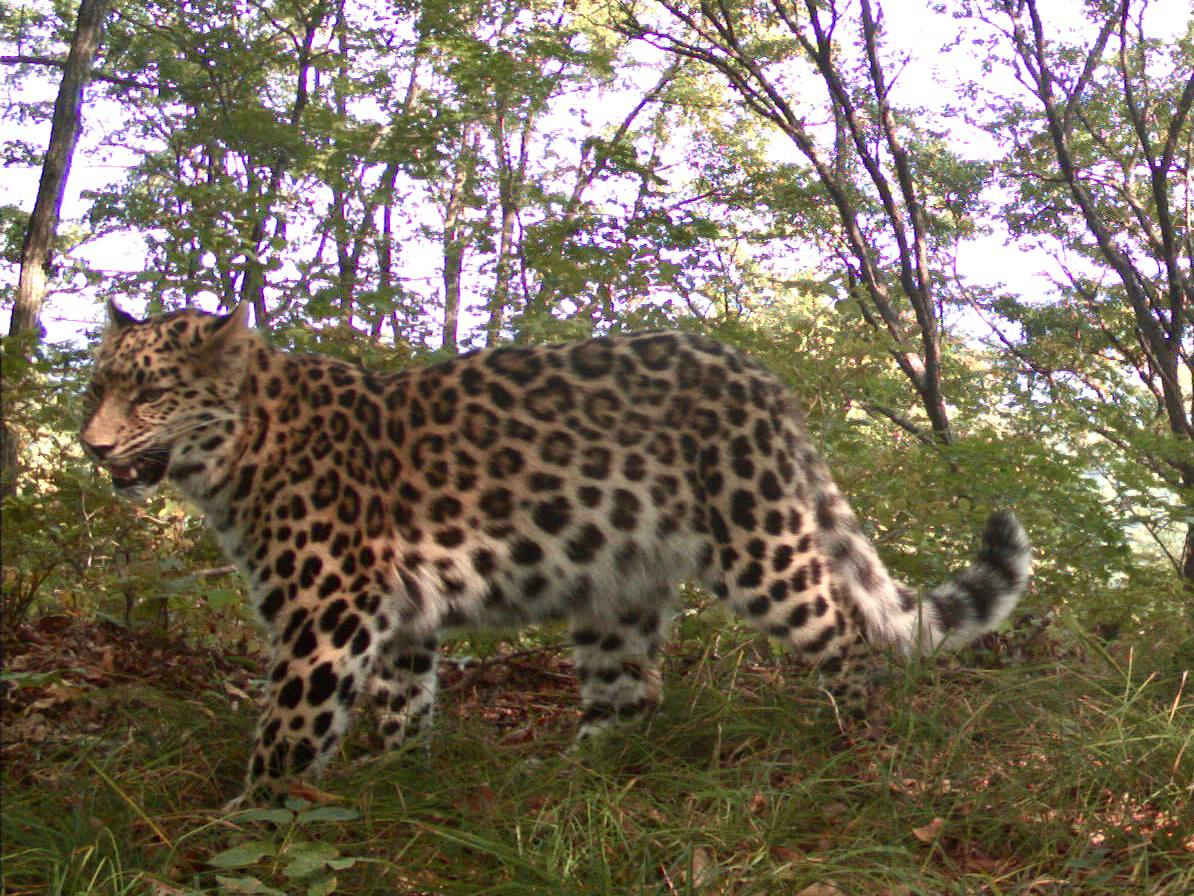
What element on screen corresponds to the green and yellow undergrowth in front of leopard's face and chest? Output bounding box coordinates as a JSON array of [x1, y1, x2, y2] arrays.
[[0, 334, 232, 627]]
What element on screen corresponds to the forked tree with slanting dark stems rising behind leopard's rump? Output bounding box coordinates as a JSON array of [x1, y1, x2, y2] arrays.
[[623, 0, 993, 444]]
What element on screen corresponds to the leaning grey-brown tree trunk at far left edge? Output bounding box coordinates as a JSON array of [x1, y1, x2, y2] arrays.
[[0, 0, 107, 496]]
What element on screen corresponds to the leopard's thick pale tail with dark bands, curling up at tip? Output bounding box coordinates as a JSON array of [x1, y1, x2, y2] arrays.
[[817, 477, 1032, 655]]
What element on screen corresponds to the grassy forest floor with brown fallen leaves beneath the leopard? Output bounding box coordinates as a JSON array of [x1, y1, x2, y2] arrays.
[[0, 612, 1194, 896]]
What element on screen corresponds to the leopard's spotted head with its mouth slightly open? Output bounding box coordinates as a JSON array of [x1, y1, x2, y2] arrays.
[[80, 302, 256, 501]]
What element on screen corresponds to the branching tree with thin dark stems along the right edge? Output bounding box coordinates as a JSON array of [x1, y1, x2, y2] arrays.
[[968, 0, 1194, 589]]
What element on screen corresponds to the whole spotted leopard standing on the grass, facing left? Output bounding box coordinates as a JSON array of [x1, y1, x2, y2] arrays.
[[80, 303, 1030, 808]]
